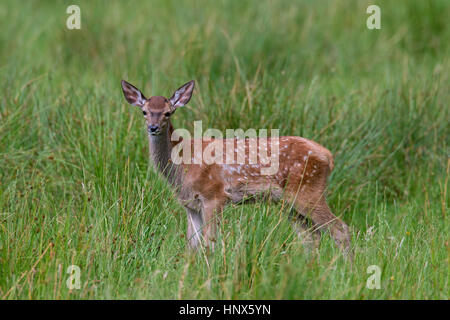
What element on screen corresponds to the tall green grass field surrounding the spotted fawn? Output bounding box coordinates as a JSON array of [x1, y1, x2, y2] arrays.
[[0, 0, 450, 299]]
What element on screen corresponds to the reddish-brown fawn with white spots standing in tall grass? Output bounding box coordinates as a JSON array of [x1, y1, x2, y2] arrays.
[[122, 80, 350, 252]]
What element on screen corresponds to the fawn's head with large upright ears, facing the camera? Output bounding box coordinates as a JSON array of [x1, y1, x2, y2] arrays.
[[122, 80, 194, 136]]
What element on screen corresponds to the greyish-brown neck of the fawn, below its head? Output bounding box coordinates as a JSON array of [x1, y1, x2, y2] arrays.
[[148, 122, 178, 184]]
